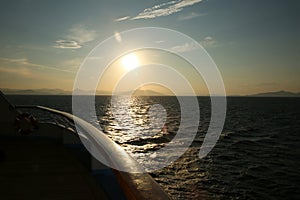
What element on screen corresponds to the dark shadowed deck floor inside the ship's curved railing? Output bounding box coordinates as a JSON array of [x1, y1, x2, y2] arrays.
[[0, 136, 106, 199]]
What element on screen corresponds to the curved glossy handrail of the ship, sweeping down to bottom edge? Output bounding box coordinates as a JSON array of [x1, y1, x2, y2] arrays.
[[15, 105, 170, 199]]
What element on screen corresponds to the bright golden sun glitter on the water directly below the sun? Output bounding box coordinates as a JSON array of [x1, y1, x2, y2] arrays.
[[99, 96, 180, 149]]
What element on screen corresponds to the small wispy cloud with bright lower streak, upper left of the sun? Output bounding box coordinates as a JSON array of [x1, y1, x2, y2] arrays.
[[53, 24, 97, 49]]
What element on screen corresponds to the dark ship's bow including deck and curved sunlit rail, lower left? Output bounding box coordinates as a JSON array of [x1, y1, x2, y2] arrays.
[[0, 91, 170, 200]]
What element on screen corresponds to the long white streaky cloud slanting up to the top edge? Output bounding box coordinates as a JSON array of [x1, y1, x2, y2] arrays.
[[130, 0, 202, 20]]
